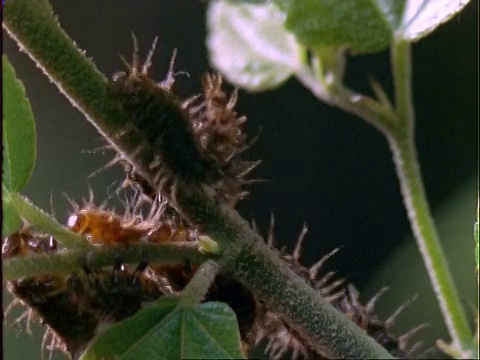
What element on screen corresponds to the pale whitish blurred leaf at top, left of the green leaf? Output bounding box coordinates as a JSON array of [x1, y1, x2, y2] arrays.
[[207, 1, 303, 91]]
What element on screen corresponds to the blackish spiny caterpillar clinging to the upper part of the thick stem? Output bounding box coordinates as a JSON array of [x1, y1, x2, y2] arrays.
[[109, 35, 220, 194]]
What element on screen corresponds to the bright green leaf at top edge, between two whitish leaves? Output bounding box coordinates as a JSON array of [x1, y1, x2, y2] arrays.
[[275, 0, 405, 53]]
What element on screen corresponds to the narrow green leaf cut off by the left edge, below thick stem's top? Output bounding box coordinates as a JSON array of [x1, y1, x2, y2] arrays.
[[2, 56, 37, 192]]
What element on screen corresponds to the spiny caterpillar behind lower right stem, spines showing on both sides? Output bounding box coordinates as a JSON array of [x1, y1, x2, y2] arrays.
[[254, 216, 425, 359]]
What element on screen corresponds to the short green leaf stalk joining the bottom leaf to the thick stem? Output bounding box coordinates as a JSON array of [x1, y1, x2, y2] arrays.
[[180, 260, 219, 307]]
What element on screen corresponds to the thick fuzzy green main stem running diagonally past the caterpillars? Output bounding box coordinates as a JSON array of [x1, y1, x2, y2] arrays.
[[3, 0, 391, 359]]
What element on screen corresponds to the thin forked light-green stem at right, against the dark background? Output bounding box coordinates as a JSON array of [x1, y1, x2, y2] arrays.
[[296, 31, 472, 347]]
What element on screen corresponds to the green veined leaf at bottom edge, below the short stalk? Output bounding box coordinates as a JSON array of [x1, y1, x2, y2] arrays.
[[81, 298, 244, 360]]
